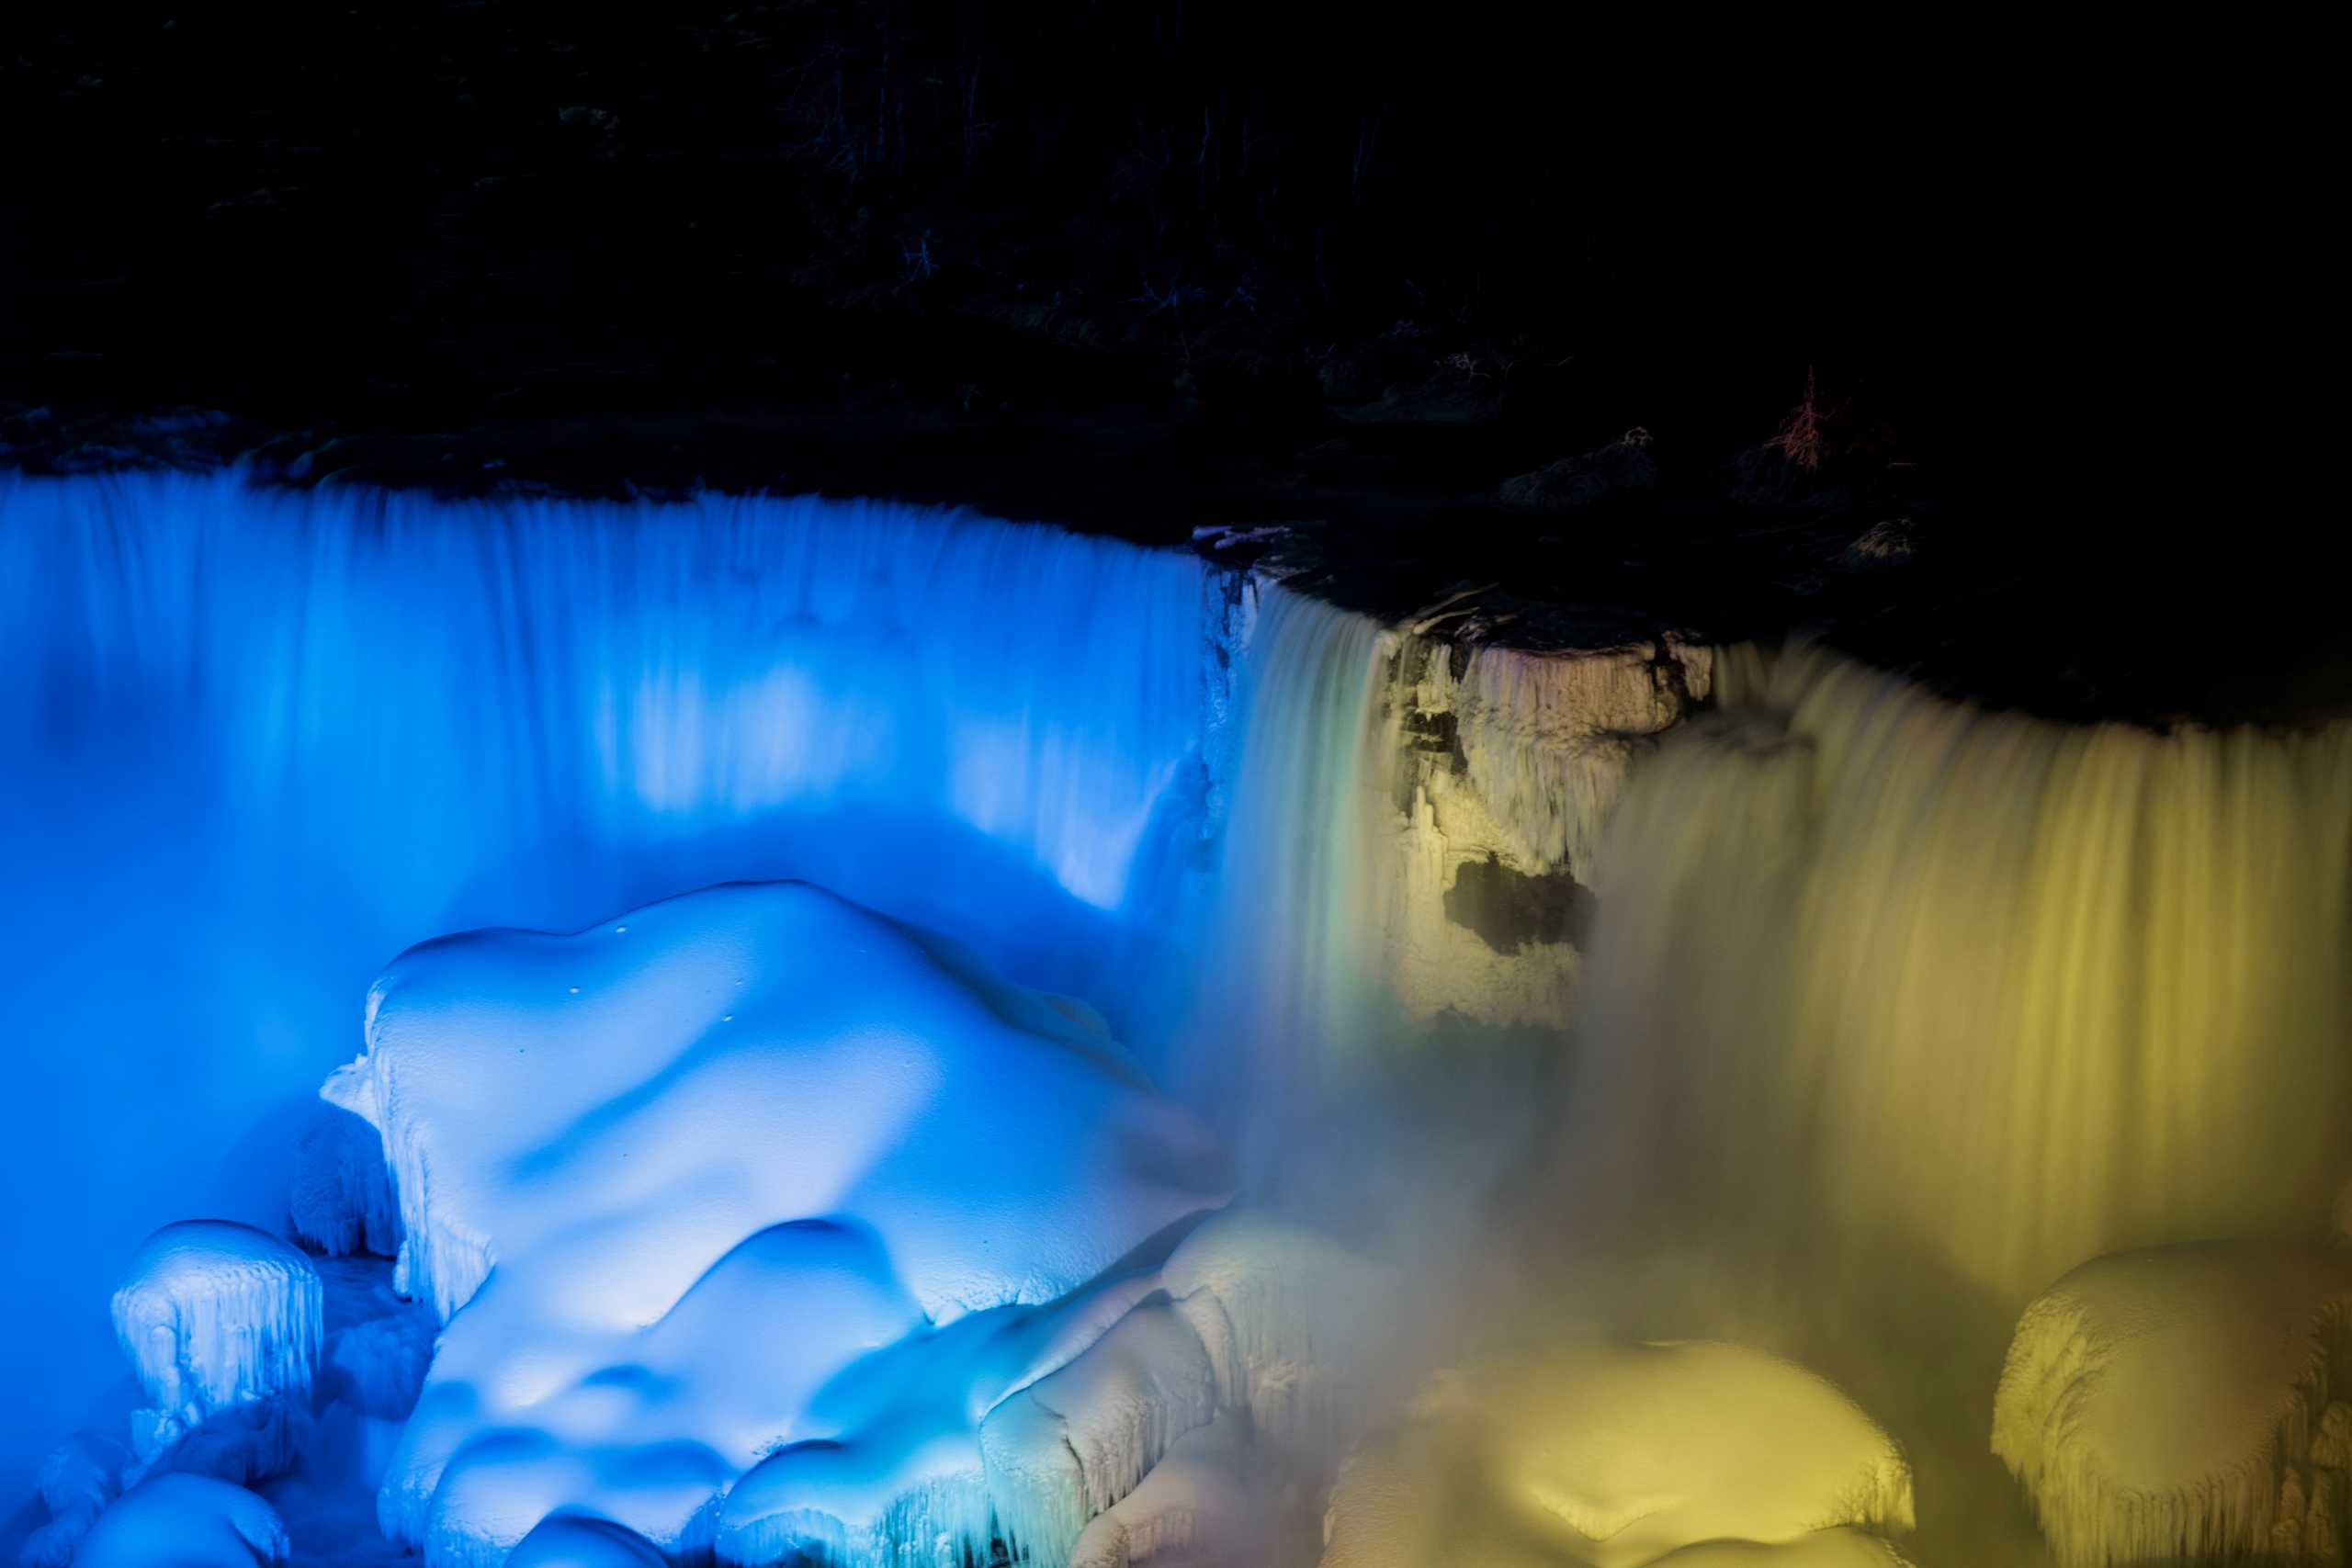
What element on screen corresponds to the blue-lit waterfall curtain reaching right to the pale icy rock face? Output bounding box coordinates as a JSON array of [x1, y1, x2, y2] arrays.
[[0, 475, 1378, 1495]]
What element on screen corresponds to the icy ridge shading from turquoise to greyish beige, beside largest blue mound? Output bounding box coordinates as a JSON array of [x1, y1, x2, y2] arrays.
[[715, 1211, 1387, 1568]]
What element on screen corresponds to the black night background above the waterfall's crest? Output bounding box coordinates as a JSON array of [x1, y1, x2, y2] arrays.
[[0, 0, 2343, 719]]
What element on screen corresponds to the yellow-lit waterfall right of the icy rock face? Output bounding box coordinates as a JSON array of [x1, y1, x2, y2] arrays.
[[1564, 649, 2352, 1309]]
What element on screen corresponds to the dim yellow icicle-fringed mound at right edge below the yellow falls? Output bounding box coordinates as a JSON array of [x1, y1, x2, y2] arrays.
[[1992, 1244, 2352, 1568]]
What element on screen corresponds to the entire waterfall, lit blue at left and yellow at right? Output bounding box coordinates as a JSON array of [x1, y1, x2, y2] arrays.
[[0, 465, 2352, 1561]]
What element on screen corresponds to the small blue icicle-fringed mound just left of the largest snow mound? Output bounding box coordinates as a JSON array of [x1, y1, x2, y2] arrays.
[[113, 1220, 324, 1479]]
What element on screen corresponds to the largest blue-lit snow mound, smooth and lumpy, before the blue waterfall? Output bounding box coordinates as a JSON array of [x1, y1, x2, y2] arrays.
[[345, 884, 1223, 1563]]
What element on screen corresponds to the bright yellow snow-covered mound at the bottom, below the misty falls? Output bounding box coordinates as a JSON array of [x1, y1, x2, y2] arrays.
[[1324, 1342, 1912, 1568]]
